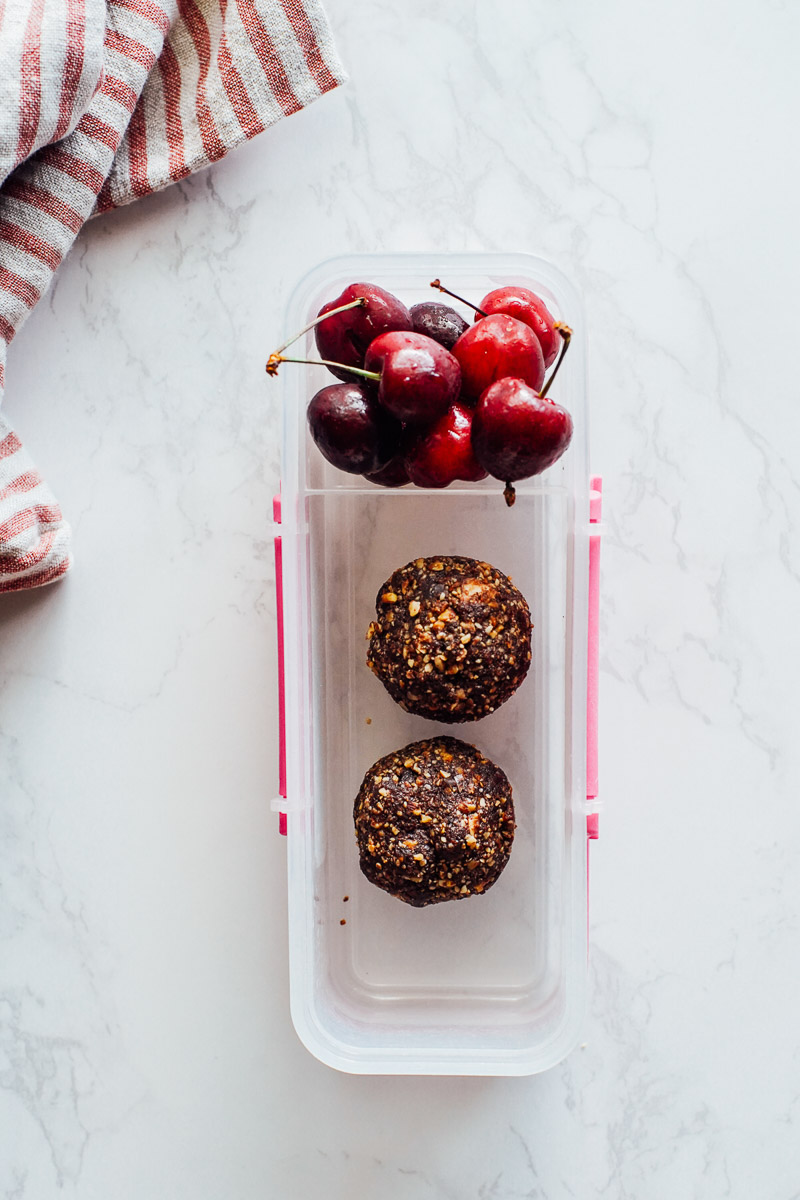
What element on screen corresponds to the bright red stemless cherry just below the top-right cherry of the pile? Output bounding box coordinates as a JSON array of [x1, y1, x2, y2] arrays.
[[453, 313, 545, 404]]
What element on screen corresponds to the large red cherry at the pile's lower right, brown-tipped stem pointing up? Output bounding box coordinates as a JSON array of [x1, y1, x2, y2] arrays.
[[473, 379, 572, 504]]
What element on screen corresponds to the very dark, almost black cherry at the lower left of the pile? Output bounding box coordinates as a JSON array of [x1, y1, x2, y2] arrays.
[[307, 383, 402, 475]]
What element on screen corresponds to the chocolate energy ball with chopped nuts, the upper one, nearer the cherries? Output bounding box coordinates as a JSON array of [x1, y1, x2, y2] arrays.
[[367, 556, 531, 724]]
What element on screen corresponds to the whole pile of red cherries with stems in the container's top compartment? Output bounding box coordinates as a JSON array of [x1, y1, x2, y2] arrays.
[[266, 280, 572, 504]]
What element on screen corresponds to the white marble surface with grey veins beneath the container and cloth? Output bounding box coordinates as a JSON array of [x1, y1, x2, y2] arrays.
[[0, 0, 800, 1200]]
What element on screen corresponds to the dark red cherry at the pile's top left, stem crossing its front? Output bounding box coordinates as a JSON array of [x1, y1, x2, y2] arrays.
[[314, 283, 411, 383]]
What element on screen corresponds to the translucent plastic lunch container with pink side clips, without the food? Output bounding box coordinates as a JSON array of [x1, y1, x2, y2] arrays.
[[272, 254, 600, 1075]]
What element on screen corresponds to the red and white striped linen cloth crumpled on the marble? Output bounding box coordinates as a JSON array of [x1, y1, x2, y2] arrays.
[[0, 0, 345, 592]]
